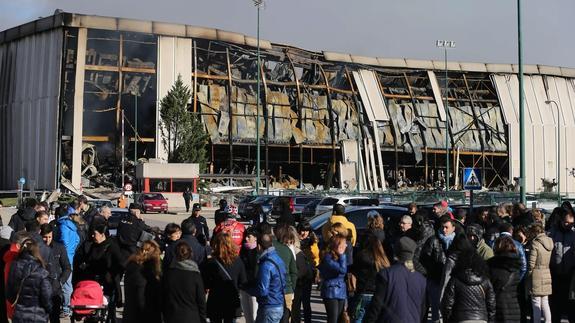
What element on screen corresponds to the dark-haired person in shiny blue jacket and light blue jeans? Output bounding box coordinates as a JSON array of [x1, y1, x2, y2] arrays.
[[248, 233, 287, 323]]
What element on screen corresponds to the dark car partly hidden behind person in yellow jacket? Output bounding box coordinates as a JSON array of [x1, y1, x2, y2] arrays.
[[309, 205, 408, 247]]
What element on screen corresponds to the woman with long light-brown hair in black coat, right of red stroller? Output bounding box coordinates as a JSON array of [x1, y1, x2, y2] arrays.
[[122, 240, 162, 323]]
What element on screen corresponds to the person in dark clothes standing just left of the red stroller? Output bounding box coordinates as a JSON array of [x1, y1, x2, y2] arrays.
[[40, 223, 72, 322]]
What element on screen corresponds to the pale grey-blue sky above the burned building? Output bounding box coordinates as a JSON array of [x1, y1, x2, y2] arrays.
[[0, 0, 575, 68]]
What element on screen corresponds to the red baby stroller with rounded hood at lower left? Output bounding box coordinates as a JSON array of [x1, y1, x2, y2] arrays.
[[70, 280, 108, 323]]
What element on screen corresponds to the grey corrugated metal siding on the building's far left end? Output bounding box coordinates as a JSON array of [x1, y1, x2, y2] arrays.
[[0, 28, 63, 189]]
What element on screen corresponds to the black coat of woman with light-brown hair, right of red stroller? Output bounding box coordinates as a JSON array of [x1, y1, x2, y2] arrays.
[[122, 261, 162, 323]]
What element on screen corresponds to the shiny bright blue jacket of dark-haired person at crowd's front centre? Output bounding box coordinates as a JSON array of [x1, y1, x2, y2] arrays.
[[252, 247, 288, 308]]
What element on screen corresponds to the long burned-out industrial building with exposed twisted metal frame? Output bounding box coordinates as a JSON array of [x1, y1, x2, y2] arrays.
[[0, 13, 575, 193]]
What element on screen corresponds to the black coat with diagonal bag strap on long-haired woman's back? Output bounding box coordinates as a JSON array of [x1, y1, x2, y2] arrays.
[[202, 257, 247, 318]]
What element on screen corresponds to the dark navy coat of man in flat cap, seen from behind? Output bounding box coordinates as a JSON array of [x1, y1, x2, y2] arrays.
[[363, 263, 426, 323]]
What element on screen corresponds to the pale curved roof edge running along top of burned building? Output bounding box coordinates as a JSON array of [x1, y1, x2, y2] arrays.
[[0, 12, 575, 77]]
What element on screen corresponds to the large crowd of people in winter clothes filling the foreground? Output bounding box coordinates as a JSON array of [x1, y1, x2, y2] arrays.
[[0, 196, 575, 323]]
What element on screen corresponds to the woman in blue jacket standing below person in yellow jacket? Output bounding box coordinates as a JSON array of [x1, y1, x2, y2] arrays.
[[319, 234, 347, 323]]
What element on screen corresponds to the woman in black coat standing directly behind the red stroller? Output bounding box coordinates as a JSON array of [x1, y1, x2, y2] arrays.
[[72, 225, 125, 322]]
